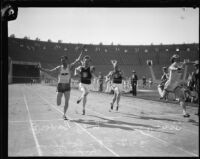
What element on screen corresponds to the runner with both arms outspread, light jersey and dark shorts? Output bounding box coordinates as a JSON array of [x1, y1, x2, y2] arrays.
[[39, 51, 82, 120]]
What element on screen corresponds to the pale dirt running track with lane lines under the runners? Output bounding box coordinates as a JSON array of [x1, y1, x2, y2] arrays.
[[8, 84, 199, 156]]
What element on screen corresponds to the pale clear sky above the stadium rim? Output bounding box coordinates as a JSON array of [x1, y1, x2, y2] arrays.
[[8, 8, 199, 45]]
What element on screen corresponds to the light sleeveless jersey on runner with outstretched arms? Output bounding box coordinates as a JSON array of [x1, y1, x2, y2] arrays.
[[58, 65, 71, 83]]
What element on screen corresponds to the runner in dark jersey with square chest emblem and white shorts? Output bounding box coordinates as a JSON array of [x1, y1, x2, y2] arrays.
[[74, 55, 96, 115]]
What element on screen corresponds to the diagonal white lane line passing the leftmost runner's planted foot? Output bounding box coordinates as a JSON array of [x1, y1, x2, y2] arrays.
[[26, 87, 119, 156]]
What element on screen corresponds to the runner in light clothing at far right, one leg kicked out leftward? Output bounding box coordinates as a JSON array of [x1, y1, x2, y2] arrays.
[[158, 54, 196, 117]]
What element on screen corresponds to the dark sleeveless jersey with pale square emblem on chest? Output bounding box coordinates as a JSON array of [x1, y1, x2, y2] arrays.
[[81, 67, 92, 84]]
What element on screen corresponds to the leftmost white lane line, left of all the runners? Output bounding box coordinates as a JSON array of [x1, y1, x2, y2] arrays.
[[23, 93, 42, 156]]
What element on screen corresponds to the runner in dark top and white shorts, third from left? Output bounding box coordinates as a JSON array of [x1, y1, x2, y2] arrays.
[[106, 60, 124, 111]]
